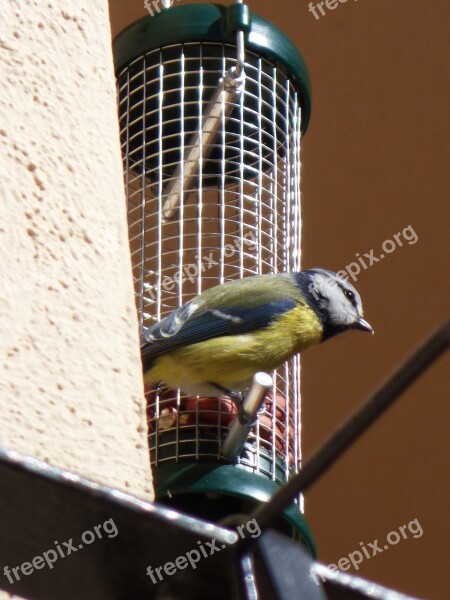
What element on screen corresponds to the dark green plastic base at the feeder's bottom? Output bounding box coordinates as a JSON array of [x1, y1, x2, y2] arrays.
[[153, 462, 316, 558]]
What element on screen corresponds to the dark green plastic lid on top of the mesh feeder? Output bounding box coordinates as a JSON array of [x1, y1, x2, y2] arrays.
[[113, 4, 311, 133]]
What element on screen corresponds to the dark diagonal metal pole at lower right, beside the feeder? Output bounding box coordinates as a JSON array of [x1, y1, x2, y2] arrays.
[[238, 321, 450, 550]]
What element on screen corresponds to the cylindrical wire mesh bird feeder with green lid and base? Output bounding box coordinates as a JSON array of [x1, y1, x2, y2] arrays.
[[114, 3, 313, 549]]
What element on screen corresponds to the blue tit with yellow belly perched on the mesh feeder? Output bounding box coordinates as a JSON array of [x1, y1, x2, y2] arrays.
[[141, 269, 373, 397]]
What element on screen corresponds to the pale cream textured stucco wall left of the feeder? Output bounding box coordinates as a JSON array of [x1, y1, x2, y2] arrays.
[[0, 0, 151, 592]]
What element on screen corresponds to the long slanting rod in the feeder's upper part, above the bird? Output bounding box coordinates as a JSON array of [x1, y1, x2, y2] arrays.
[[162, 69, 244, 222]]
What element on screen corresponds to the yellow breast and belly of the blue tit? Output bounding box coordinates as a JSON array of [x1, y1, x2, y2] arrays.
[[146, 303, 323, 388]]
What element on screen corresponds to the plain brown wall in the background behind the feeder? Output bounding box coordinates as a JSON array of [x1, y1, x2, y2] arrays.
[[110, 0, 450, 599]]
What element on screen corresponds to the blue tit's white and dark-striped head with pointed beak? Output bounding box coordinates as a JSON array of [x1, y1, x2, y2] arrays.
[[301, 269, 373, 340]]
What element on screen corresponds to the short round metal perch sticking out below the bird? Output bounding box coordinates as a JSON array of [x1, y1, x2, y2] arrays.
[[220, 372, 273, 460]]
